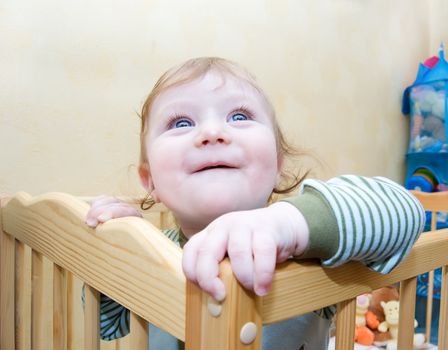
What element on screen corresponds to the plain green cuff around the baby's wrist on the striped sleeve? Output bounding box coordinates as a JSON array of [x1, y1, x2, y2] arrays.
[[283, 187, 339, 259]]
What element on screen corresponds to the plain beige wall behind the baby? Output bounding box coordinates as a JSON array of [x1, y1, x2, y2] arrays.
[[0, 0, 448, 195]]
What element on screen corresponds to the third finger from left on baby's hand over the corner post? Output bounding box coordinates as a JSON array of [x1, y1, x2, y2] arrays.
[[227, 230, 254, 290]]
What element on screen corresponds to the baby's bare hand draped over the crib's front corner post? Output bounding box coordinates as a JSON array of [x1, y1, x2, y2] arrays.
[[182, 202, 309, 300]]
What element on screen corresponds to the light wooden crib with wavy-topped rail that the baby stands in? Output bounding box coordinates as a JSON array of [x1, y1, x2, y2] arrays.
[[0, 193, 448, 350]]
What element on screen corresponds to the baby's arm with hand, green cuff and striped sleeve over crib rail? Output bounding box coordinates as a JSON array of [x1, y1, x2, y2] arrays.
[[183, 176, 424, 300]]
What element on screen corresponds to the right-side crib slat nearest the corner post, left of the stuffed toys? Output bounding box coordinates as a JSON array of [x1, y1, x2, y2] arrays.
[[336, 298, 356, 350]]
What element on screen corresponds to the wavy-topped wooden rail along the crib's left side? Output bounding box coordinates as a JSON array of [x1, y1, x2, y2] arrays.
[[1, 193, 186, 349]]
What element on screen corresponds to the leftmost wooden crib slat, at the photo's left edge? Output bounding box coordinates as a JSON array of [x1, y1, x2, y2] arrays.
[[0, 223, 15, 349]]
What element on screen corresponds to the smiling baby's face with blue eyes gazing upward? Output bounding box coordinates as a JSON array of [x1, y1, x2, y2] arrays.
[[145, 72, 279, 234]]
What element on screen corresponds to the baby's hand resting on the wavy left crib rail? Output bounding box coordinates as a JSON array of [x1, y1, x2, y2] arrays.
[[86, 196, 142, 227]]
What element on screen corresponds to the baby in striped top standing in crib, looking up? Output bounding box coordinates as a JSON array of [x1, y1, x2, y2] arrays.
[[86, 57, 424, 350]]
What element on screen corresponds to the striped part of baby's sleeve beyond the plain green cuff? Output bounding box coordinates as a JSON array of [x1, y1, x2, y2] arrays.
[[292, 175, 425, 273]]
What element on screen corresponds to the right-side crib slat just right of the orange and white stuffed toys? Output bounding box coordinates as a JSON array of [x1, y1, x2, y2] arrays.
[[398, 277, 417, 349]]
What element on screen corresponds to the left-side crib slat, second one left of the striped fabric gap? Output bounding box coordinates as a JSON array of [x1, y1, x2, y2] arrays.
[[53, 264, 67, 350]]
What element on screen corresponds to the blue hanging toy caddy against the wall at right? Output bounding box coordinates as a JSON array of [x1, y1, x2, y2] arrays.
[[402, 45, 448, 229]]
